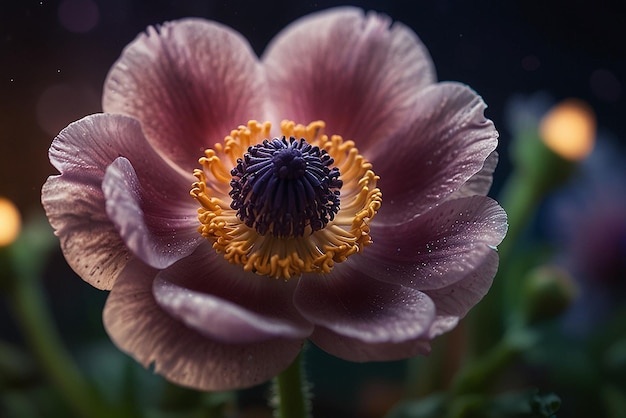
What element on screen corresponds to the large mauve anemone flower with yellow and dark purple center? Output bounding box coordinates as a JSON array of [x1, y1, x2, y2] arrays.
[[42, 8, 506, 390]]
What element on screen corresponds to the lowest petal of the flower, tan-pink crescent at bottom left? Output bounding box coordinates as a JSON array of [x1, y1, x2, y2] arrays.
[[103, 260, 304, 391]]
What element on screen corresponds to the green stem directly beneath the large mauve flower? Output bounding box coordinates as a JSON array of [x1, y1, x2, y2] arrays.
[[273, 353, 311, 418]]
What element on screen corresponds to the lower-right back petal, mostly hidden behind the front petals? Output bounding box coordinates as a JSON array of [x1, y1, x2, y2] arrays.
[[424, 251, 498, 338]]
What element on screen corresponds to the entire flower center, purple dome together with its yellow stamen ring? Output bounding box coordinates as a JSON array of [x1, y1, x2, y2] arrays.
[[191, 121, 382, 279]]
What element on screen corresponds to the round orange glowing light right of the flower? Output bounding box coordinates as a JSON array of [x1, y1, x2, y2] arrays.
[[539, 99, 596, 161]]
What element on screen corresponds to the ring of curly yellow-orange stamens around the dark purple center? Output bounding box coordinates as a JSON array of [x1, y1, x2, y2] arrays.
[[191, 121, 382, 279]]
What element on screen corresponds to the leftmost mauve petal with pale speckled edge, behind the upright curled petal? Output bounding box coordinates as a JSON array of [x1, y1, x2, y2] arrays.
[[41, 114, 194, 289]]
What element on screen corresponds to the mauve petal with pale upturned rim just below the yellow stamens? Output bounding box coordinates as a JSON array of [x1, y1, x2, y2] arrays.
[[154, 242, 313, 344]]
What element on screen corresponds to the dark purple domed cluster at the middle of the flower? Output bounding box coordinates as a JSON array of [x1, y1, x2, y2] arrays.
[[230, 137, 343, 238]]
